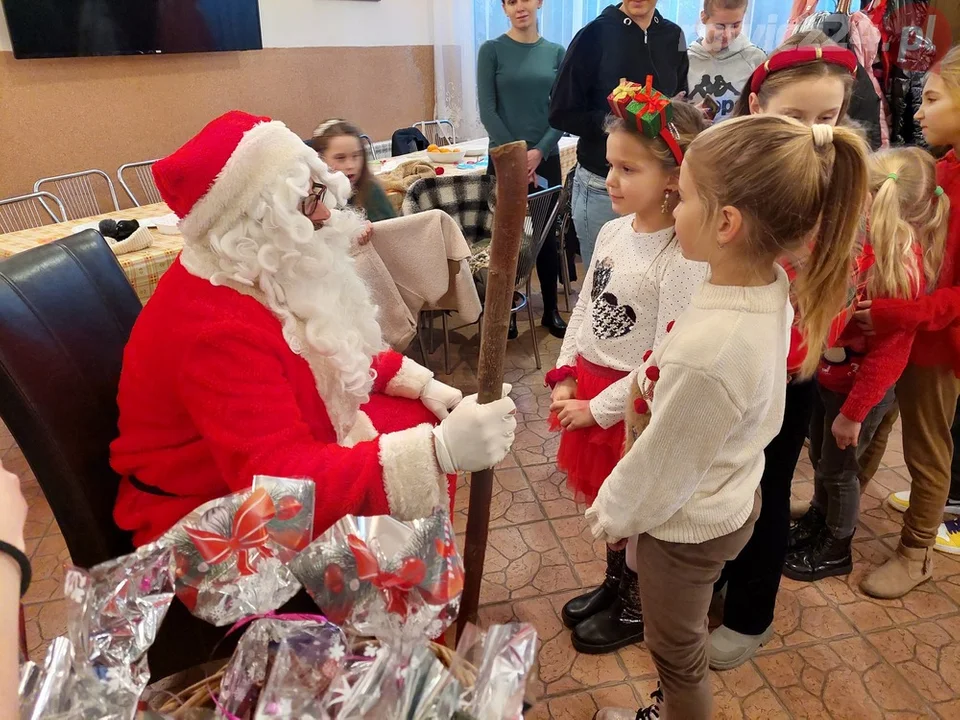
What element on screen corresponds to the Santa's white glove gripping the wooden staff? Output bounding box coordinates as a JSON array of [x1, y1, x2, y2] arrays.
[[433, 385, 517, 475]]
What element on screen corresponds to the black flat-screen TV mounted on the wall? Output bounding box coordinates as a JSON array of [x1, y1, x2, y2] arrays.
[[3, 0, 263, 58]]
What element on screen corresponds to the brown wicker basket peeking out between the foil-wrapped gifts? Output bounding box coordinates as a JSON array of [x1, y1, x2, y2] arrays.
[[147, 641, 477, 720]]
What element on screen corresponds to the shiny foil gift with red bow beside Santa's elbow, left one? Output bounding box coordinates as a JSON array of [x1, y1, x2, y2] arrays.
[[159, 476, 314, 626]]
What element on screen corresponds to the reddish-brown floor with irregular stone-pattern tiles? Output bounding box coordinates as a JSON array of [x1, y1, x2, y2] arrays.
[[11, 288, 960, 720]]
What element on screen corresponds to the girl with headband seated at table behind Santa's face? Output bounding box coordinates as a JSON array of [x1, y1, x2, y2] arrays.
[[307, 120, 397, 222]]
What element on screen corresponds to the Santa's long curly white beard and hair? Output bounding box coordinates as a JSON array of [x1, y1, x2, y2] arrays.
[[182, 152, 385, 441]]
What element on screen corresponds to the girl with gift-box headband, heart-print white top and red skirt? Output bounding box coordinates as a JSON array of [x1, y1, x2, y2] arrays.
[[547, 85, 707, 654]]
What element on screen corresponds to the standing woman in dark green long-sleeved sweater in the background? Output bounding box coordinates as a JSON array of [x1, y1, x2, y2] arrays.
[[477, 0, 567, 337]]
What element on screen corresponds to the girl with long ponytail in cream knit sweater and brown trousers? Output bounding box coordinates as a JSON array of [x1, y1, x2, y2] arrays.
[[587, 116, 867, 720]]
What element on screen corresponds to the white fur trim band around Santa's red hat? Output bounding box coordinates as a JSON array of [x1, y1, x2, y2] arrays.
[[180, 120, 317, 239]]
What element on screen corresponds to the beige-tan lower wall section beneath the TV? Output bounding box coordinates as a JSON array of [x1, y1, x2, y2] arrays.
[[0, 45, 434, 203]]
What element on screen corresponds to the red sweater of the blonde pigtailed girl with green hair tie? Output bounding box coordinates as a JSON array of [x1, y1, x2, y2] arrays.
[[817, 244, 924, 422]]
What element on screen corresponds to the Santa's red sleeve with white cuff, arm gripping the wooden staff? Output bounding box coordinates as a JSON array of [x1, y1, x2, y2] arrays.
[[178, 326, 447, 533]]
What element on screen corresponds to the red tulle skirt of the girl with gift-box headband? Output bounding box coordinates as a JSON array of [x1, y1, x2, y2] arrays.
[[550, 356, 629, 505]]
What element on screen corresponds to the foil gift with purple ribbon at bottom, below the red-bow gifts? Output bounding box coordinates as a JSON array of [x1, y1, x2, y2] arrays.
[[218, 618, 346, 720]]
